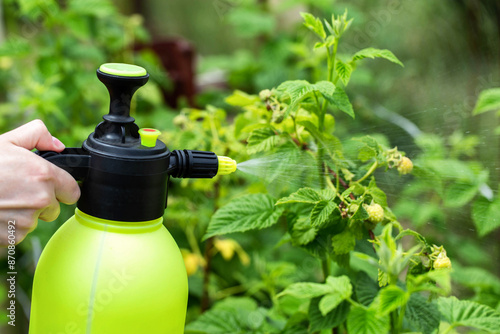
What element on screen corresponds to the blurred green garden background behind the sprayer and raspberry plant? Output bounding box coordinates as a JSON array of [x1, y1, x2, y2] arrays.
[[0, 0, 500, 333]]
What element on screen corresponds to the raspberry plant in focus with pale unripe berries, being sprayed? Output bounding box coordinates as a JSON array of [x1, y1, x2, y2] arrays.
[[177, 12, 500, 334]]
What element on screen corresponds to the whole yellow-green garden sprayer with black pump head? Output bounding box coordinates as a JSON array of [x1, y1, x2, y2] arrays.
[[29, 64, 236, 334]]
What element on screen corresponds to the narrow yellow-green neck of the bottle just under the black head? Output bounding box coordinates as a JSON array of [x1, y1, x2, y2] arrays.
[[75, 208, 163, 234]]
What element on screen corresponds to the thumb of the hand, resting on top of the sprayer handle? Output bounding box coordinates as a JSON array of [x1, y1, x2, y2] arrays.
[[2, 119, 64, 152]]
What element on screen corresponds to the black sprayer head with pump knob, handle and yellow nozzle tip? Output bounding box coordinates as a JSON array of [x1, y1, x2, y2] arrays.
[[37, 63, 236, 222]]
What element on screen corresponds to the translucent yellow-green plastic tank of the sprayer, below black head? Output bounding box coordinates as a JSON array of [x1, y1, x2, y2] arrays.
[[29, 209, 188, 334]]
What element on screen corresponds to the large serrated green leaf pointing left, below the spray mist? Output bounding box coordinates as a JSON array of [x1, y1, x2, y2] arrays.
[[203, 194, 284, 240]]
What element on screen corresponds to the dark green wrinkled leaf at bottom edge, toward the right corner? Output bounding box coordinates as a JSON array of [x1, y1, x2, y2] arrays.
[[405, 293, 441, 334]]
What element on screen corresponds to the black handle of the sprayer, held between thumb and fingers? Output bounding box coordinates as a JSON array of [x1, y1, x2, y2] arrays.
[[35, 147, 90, 181]]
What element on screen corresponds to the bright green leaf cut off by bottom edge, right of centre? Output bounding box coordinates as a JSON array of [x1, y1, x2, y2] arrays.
[[347, 306, 390, 334]]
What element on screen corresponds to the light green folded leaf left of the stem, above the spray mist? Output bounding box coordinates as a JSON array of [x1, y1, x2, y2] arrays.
[[278, 80, 335, 118]]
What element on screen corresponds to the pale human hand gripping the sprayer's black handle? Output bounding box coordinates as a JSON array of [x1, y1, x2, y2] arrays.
[[0, 120, 80, 246]]
